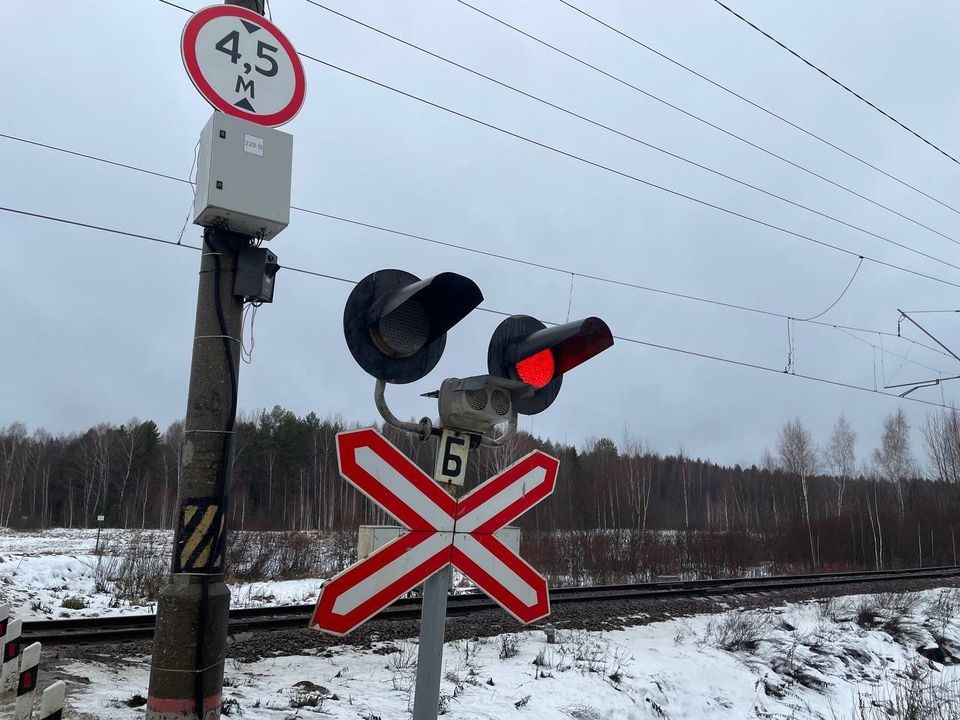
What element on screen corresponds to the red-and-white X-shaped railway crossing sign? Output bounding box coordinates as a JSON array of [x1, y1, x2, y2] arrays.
[[310, 429, 560, 635]]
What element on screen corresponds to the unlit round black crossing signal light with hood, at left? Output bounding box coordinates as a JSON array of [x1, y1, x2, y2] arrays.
[[343, 270, 483, 384]]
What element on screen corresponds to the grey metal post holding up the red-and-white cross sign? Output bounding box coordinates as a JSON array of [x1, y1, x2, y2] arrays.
[[413, 446, 467, 720]]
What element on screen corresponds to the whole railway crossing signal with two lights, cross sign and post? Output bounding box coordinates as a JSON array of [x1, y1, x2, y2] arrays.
[[318, 270, 613, 720]]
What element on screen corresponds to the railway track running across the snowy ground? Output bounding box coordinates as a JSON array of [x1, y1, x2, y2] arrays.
[[23, 565, 960, 646]]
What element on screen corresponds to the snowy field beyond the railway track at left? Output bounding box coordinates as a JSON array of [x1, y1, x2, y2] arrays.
[[0, 529, 337, 619]]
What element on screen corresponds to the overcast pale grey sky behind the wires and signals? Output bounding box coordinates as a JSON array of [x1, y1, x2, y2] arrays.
[[0, 0, 960, 463]]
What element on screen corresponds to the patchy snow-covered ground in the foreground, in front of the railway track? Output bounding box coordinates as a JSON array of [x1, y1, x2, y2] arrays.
[[54, 589, 960, 720]]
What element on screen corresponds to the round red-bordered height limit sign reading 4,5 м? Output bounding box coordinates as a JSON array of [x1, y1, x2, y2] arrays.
[[180, 5, 307, 127]]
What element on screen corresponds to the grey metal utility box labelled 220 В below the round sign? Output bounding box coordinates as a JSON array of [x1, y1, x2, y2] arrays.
[[193, 112, 293, 239]]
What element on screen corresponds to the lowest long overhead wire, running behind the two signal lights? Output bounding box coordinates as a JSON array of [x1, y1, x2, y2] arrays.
[[0, 206, 953, 410]]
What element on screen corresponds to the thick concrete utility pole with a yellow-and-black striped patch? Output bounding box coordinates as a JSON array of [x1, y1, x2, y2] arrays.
[[146, 7, 263, 720]]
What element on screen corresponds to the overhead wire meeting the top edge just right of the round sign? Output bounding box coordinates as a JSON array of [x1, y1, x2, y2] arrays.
[[305, 0, 960, 270]]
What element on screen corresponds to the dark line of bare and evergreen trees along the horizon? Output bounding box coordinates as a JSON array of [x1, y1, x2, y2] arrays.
[[0, 407, 960, 569]]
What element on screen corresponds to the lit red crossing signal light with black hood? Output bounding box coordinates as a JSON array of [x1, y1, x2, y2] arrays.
[[487, 315, 613, 415]]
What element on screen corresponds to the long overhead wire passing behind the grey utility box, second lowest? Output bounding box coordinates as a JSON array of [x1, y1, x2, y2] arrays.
[[0, 130, 950, 357]]
